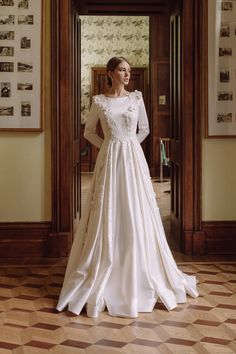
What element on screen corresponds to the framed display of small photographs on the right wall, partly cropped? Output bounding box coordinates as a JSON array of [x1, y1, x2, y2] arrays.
[[205, 0, 236, 138]]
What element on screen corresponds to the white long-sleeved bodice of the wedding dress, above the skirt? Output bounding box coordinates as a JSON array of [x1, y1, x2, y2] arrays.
[[84, 91, 149, 148]]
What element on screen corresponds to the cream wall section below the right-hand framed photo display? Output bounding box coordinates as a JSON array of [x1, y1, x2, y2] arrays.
[[202, 139, 236, 221]]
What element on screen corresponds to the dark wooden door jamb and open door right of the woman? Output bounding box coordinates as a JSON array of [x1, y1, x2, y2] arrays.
[[170, 0, 205, 254]]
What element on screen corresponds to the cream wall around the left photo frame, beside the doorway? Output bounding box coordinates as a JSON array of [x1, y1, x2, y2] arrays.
[[0, 0, 51, 222]]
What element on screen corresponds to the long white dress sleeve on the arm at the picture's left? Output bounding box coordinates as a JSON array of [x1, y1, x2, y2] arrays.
[[84, 100, 103, 149]]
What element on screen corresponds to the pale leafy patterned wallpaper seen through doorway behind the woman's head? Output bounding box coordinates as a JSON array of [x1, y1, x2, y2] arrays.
[[80, 16, 149, 123]]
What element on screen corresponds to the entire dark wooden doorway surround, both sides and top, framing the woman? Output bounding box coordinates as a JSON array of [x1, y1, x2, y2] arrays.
[[52, 0, 204, 256]]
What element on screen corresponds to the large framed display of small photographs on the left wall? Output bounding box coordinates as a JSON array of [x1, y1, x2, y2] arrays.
[[0, 0, 45, 131]]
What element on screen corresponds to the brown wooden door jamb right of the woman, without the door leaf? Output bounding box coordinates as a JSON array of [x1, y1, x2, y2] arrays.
[[181, 0, 206, 255]]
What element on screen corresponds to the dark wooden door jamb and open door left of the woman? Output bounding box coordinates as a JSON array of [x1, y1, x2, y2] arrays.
[[48, 0, 80, 257]]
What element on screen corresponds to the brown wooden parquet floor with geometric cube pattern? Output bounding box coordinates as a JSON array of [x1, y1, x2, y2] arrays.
[[0, 260, 236, 354]]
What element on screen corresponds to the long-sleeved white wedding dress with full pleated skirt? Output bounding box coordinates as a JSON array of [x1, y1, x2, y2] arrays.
[[57, 91, 198, 317]]
